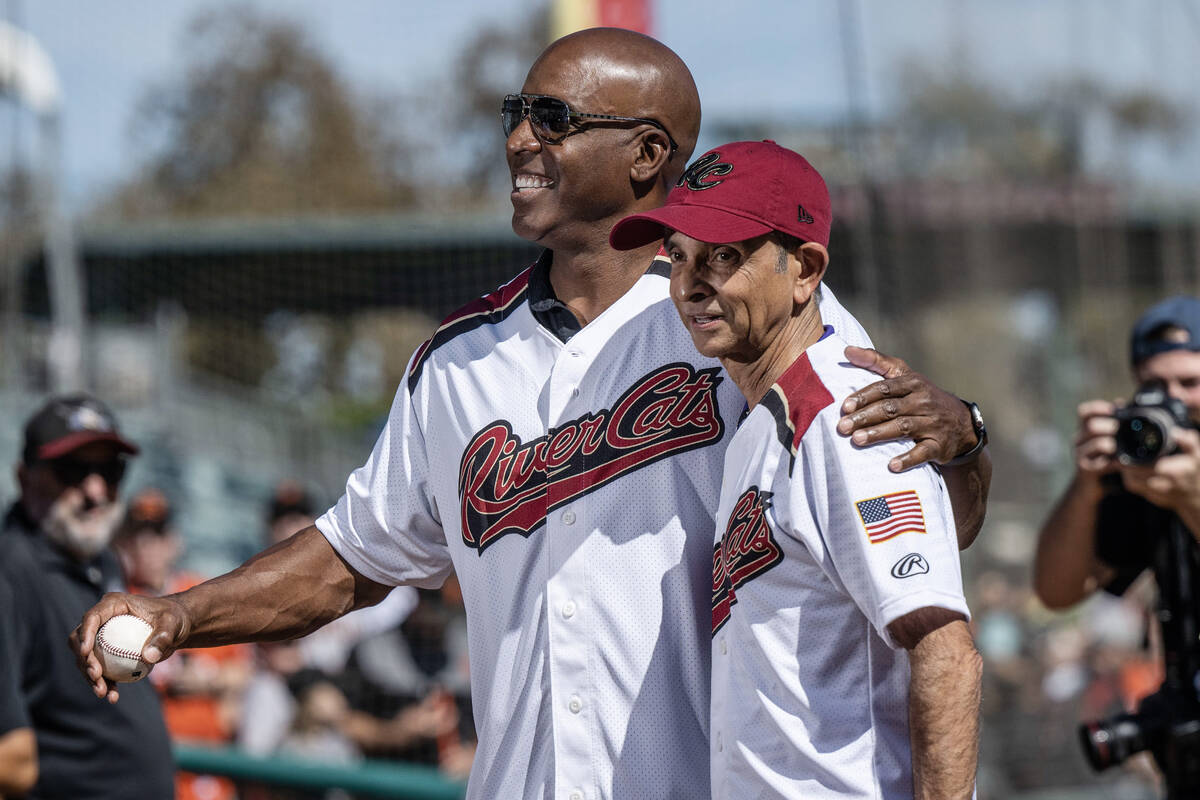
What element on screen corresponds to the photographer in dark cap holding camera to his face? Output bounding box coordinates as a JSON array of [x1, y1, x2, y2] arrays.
[[1033, 296, 1200, 800]]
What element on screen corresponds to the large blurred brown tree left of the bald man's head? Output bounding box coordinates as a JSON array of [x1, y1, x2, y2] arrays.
[[97, 7, 414, 218]]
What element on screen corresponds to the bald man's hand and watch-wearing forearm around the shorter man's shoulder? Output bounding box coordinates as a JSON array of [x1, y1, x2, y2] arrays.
[[838, 347, 991, 549]]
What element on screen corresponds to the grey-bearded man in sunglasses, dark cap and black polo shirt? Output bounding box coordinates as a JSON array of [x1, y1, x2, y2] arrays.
[[0, 395, 174, 799]]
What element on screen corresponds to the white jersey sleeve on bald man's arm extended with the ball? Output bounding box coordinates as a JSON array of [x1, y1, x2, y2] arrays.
[[317, 347, 451, 588]]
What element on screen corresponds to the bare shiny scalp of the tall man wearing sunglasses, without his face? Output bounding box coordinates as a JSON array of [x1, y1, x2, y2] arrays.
[[529, 28, 700, 182]]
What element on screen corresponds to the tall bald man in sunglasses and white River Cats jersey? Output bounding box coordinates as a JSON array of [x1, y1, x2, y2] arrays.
[[76, 29, 986, 800]]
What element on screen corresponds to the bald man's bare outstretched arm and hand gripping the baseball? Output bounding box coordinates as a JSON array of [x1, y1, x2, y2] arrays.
[[71, 527, 391, 703]]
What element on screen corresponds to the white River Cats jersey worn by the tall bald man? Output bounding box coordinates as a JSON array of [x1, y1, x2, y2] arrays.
[[317, 253, 866, 800]]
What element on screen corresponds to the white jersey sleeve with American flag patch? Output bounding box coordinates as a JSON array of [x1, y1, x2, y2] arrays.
[[788, 409, 970, 648]]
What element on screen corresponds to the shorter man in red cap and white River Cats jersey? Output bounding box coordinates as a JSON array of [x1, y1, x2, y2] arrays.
[[612, 142, 980, 800]]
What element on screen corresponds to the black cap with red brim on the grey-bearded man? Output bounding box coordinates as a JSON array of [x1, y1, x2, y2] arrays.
[[22, 392, 138, 464]]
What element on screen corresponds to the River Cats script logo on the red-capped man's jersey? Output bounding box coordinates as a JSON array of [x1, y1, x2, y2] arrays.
[[713, 486, 784, 633]]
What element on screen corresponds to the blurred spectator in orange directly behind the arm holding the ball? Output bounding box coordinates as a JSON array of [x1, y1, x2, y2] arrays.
[[113, 488, 251, 800]]
